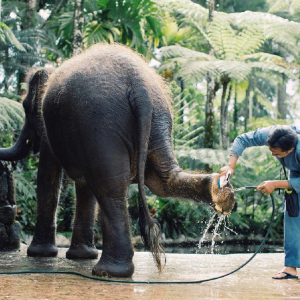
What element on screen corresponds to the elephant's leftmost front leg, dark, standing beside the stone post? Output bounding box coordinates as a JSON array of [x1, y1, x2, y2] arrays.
[[27, 140, 62, 257]]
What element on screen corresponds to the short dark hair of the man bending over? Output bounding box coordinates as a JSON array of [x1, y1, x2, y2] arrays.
[[267, 125, 298, 152]]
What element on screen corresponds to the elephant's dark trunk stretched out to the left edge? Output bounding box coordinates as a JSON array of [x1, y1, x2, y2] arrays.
[[0, 123, 31, 161]]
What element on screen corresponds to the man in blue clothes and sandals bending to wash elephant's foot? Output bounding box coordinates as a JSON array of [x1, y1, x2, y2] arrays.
[[219, 125, 300, 279]]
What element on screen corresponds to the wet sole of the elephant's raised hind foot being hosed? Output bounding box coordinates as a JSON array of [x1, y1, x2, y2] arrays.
[[211, 176, 235, 215]]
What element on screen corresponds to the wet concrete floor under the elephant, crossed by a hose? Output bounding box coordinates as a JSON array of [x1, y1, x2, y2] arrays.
[[0, 245, 300, 300]]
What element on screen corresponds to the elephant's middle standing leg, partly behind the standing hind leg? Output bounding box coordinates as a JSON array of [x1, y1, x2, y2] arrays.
[[66, 182, 98, 259]]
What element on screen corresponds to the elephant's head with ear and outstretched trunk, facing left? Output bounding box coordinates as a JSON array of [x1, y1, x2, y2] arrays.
[[0, 68, 53, 161]]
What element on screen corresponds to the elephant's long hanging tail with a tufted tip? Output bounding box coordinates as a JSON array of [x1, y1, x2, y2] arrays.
[[129, 85, 164, 272]]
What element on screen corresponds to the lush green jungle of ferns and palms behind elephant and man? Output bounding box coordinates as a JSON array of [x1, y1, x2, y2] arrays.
[[0, 0, 300, 253]]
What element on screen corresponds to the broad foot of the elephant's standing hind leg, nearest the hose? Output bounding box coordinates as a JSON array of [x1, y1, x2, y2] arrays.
[[92, 260, 134, 277]]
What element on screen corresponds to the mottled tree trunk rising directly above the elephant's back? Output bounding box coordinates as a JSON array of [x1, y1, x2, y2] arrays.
[[73, 0, 84, 55]]
